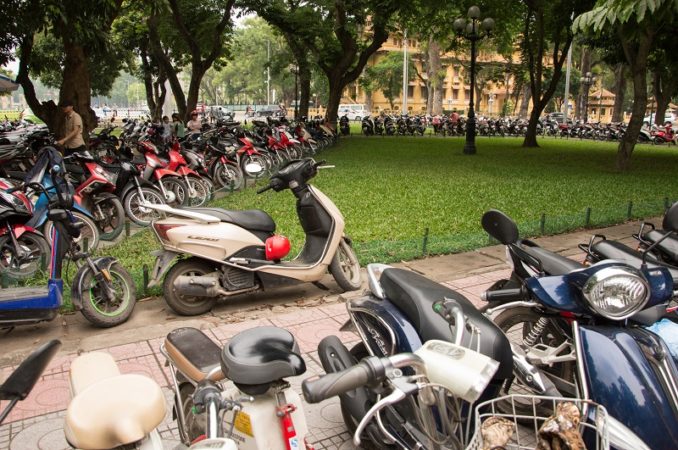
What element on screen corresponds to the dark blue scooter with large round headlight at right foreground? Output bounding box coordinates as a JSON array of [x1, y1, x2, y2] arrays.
[[485, 204, 678, 449]]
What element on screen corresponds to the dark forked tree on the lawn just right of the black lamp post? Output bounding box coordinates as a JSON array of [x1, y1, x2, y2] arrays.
[[521, 0, 594, 147]]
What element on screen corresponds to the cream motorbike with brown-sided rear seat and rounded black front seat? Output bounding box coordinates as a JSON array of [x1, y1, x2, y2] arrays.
[[160, 327, 313, 450]]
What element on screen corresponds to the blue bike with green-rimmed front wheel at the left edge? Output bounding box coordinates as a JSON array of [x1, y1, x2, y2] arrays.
[[0, 147, 136, 327]]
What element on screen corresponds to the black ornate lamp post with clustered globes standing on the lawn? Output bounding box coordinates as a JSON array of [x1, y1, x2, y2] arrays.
[[452, 6, 494, 155]]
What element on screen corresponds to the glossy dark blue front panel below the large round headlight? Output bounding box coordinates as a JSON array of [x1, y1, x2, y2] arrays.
[[579, 325, 678, 449]]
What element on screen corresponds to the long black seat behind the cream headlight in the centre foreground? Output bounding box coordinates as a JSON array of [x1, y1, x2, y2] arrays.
[[380, 268, 513, 379]]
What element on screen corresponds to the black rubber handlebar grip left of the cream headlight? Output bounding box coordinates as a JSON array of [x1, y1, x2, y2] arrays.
[[301, 358, 379, 403]]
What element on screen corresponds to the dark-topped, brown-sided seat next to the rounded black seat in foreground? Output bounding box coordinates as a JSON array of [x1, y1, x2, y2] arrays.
[[165, 327, 224, 383]]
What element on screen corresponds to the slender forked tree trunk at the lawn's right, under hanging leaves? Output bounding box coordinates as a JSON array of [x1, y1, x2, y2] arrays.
[[617, 26, 653, 171]]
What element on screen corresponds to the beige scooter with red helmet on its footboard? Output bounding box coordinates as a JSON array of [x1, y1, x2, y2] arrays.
[[148, 158, 361, 315]]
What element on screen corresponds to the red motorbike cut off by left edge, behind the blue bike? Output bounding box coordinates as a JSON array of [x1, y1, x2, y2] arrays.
[[0, 178, 50, 279]]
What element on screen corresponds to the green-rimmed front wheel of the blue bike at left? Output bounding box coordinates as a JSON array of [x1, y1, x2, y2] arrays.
[[80, 262, 137, 328]]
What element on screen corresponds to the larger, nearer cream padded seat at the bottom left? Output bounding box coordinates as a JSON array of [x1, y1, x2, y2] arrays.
[[64, 374, 166, 449]]
